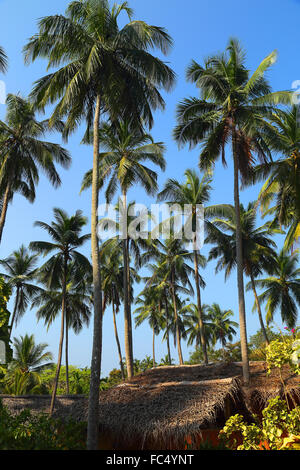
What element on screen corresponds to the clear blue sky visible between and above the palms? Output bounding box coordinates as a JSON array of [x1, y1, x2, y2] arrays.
[[0, 0, 300, 374]]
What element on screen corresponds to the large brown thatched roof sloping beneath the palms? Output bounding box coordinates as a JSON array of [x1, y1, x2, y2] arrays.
[[70, 362, 300, 442]]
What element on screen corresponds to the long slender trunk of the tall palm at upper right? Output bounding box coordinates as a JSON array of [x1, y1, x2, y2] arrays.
[[232, 131, 250, 384]]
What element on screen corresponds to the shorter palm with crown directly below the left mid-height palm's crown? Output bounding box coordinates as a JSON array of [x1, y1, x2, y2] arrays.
[[31, 263, 92, 394]]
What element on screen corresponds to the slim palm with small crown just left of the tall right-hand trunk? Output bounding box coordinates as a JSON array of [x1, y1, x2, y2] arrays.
[[158, 170, 212, 364]]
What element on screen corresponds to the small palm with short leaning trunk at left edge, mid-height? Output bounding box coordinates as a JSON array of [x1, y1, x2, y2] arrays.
[[0, 245, 40, 337]]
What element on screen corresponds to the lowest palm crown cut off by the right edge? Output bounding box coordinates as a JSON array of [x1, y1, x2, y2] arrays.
[[255, 249, 300, 328]]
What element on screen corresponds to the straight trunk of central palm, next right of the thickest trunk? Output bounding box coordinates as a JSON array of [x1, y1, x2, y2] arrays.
[[122, 191, 134, 379]]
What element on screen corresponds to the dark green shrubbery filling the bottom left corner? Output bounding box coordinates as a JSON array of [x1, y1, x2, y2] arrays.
[[0, 402, 85, 450]]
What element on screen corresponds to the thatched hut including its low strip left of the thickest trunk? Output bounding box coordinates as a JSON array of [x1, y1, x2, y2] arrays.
[[3, 362, 300, 450]]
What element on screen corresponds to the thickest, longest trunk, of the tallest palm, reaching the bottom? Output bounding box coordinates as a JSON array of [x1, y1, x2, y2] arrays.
[[87, 95, 103, 450]]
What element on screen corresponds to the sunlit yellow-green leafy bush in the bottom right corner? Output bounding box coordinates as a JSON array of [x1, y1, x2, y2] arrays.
[[219, 397, 300, 450]]
